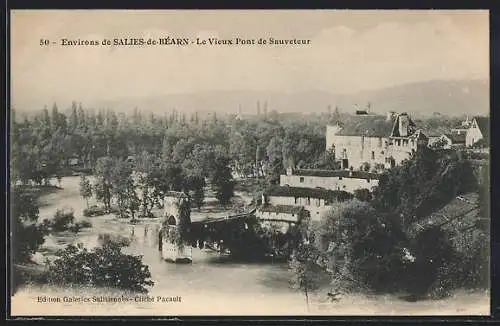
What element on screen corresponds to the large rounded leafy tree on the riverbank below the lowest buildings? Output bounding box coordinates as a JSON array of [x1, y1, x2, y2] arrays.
[[319, 200, 406, 291]]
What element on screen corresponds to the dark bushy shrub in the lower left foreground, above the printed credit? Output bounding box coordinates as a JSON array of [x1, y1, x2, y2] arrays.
[[46, 241, 154, 293]]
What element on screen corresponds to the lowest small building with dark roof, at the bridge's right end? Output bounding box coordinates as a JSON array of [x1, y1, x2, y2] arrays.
[[262, 186, 350, 220]]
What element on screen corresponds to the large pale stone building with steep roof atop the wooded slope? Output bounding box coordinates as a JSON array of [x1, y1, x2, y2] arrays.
[[326, 112, 428, 170]]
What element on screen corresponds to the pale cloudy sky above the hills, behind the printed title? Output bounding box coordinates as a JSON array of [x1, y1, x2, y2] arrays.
[[10, 10, 489, 109]]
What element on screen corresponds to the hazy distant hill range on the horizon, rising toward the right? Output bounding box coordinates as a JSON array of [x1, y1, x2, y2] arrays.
[[24, 79, 490, 116]]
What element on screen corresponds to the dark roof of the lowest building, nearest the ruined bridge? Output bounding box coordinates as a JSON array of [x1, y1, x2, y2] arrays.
[[264, 186, 353, 201]]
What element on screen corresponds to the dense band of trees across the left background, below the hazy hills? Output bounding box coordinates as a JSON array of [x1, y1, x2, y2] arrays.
[[11, 102, 331, 188]]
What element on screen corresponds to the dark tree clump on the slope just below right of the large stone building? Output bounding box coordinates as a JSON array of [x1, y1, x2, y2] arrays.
[[374, 148, 477, 224]]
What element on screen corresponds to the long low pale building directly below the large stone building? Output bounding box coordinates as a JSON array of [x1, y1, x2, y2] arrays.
[[280, 168, 379, 192]]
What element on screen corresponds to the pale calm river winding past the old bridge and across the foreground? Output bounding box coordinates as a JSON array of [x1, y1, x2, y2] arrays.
[[12, 177, 489, 316]]
